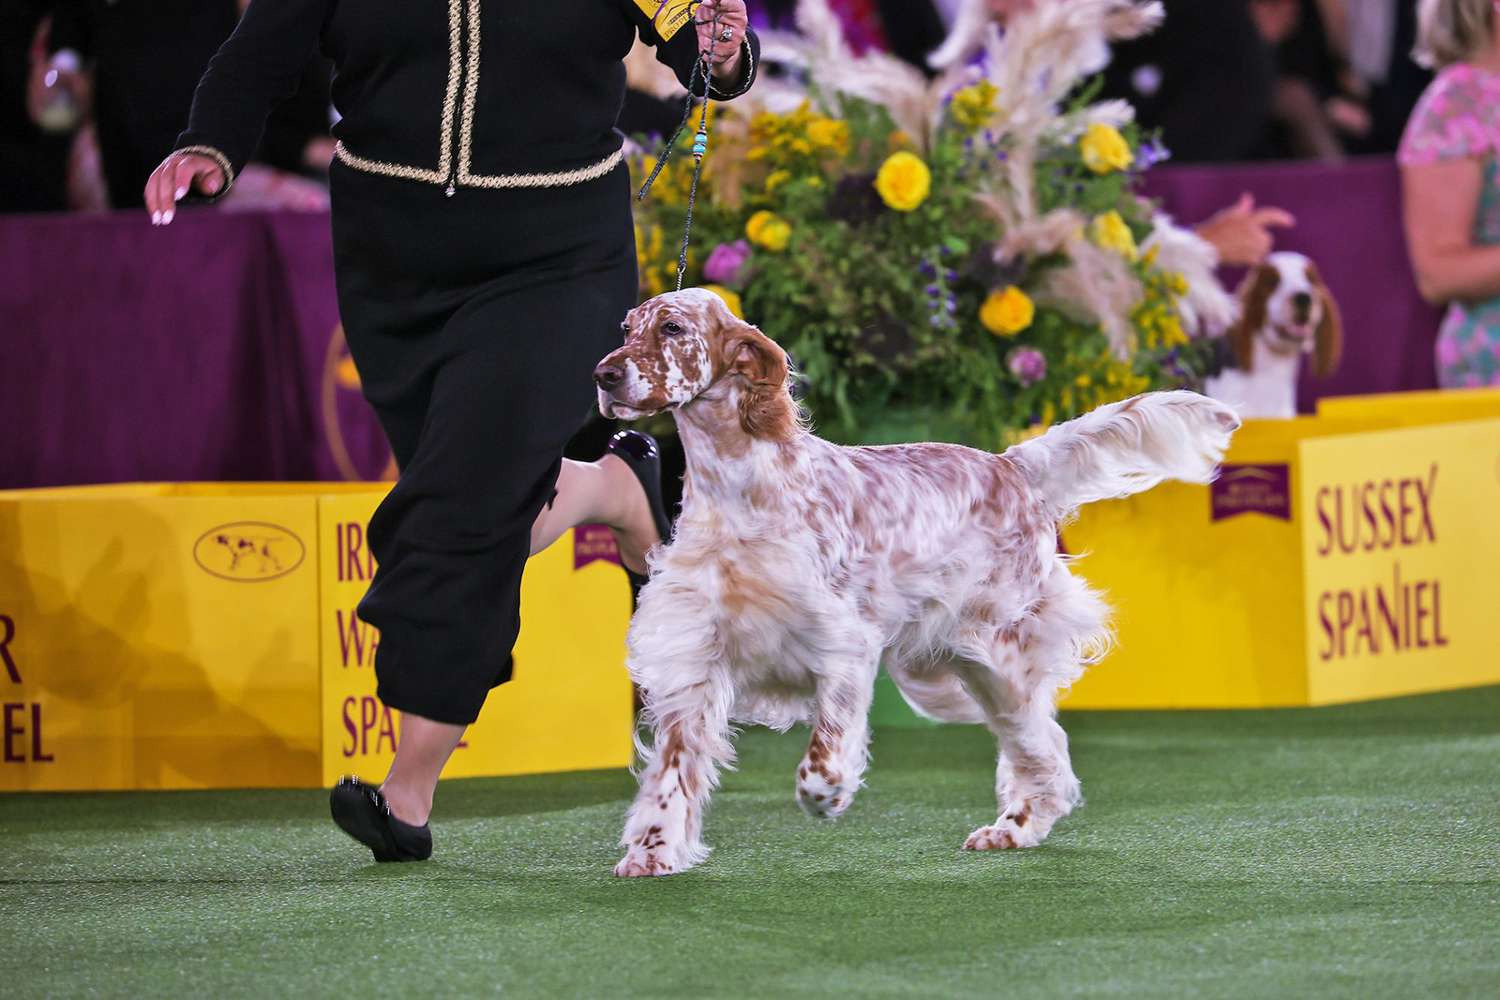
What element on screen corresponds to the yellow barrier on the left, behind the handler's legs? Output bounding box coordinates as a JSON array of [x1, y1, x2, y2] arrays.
[[0, 483, 633, 790]]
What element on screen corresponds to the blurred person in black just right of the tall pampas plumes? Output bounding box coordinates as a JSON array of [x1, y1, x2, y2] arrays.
[[1103, 0, 1275, 163]]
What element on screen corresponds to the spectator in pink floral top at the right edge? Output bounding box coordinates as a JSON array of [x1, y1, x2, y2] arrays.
[[1400, 0, 1500, 387]]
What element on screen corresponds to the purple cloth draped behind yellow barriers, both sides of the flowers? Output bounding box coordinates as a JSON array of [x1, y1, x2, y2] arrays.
[[0, 160, 1439, 487]]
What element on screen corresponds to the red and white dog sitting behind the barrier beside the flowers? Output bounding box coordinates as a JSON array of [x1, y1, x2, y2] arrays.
[[1203, 253, 1344, 418]]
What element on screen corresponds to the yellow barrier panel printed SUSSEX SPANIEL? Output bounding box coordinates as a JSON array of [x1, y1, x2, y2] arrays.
[[1299, 420, 1500, 705]]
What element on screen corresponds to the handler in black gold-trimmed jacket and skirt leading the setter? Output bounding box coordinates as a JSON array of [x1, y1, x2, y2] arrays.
[[146, 0, 759, 861]]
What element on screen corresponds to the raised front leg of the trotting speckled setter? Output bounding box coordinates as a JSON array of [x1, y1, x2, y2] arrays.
[[797, 664, 878, 819]]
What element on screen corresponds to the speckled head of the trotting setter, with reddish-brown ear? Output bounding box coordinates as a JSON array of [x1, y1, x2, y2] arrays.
[[594, 288, 798, 439]]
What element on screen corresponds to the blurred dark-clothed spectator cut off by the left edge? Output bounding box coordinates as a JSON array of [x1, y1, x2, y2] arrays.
[[0, 0, 72, 211]]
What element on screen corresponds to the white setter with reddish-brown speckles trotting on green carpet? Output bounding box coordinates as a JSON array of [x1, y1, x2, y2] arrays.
[[594, 289, 1239, 876]]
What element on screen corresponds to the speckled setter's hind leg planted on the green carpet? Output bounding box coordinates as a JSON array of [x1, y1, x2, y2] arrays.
[[956, 568, 1107, 850]]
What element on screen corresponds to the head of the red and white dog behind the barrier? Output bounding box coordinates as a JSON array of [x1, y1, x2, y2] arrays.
[[1229, 253, 1344, 375]]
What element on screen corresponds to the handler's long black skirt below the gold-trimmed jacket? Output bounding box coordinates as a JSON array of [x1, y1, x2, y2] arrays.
[[332, 163, 638, 724]]
